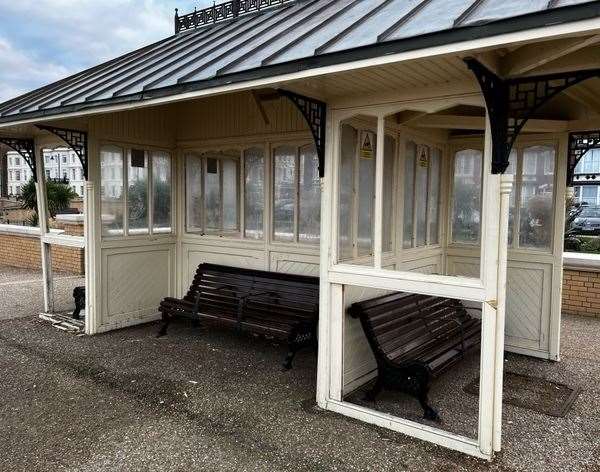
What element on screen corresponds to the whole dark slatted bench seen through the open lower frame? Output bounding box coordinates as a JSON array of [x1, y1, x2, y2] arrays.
[[349, 293, 481, 421]]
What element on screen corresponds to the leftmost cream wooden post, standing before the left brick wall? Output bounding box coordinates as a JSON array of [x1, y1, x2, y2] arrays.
[[34, 142, 54, 313]]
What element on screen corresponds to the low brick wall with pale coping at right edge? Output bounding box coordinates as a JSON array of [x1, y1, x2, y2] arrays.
[[562, 253, 600, 318]]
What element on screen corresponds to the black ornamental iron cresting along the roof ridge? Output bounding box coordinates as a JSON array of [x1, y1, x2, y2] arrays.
[[175, 0, 295, 34]]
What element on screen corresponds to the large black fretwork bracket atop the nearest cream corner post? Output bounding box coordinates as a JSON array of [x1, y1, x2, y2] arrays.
[[465, 58, 600, 179]]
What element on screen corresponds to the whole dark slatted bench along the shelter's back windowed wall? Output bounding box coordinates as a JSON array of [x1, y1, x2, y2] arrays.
[[159, 264, 319, 369]]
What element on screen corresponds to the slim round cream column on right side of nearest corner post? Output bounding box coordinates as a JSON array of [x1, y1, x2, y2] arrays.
[[493, 174, 514, 452]]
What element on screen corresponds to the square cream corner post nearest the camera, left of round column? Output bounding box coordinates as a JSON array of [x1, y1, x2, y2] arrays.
[[479, 112, 500, 456]]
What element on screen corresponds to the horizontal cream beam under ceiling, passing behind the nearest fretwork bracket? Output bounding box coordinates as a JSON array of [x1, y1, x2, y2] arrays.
[[410, 115, 569, 133]]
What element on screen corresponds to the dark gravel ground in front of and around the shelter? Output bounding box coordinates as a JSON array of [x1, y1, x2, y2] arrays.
[[0, 317, 600, 472]]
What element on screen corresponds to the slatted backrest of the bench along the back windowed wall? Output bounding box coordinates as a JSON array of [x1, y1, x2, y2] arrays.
[[184, 263, 319, 323]]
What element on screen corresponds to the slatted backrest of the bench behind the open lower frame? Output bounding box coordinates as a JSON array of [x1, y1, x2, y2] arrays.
[[349, 292, 471, 363]]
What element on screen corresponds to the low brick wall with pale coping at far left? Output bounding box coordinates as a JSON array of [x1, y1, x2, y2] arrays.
[[0, 225, 85, 275]]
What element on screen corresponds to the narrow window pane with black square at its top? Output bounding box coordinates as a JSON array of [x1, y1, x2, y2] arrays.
[[127, 149, 148, 235]]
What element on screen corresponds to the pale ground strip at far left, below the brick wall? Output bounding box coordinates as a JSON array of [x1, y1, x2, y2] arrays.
[[0, 266, 85, 320]]
